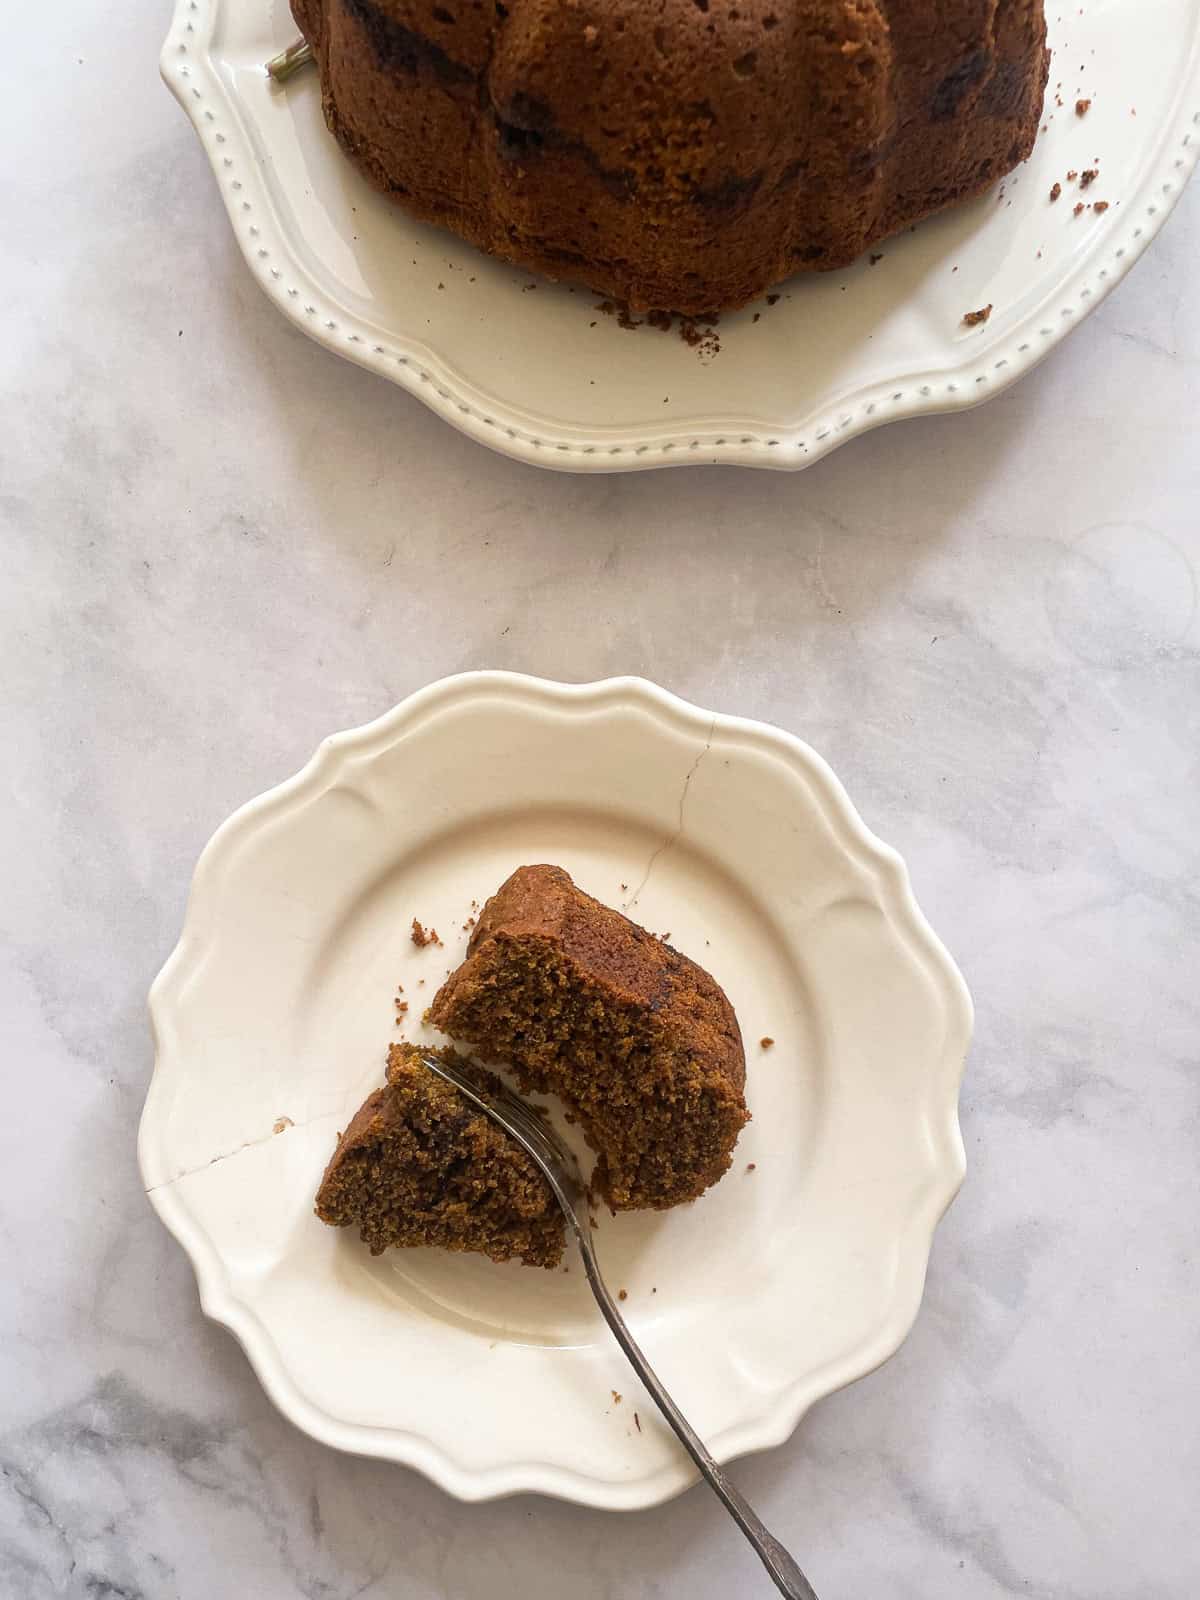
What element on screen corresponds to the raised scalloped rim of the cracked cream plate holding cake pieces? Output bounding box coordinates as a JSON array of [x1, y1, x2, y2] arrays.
[[138, 670, 973, 1510]]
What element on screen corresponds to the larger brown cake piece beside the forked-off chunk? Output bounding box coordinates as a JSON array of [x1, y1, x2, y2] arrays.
[[429, 866, 749, 1210]]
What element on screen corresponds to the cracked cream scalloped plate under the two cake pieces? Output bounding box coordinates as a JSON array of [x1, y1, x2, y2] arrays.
[[139, 672, 971, 1509]]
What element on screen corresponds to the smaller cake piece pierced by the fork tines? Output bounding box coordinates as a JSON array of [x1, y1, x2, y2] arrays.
[[317, 1045, 563, 1267]]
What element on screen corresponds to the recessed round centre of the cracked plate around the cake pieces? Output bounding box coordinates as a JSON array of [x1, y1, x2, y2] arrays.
[[290, 810, 826, 1346]]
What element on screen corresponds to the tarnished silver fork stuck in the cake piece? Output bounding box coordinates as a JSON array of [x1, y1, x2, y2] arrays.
[[421, 1053, 818, 1600]]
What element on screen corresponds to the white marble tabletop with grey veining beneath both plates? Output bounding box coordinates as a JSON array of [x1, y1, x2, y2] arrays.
[[0, 0, 1200, 1600]]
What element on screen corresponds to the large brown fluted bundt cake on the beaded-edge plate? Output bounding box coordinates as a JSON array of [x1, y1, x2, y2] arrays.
[[291, 0, 1048, 315]]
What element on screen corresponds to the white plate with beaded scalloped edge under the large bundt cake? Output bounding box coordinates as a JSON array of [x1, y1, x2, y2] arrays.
[[162, 0, 1200, 472]]
